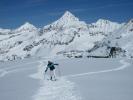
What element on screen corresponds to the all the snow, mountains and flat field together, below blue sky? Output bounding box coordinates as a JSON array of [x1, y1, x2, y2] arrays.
[[0, 11, 133, 100]]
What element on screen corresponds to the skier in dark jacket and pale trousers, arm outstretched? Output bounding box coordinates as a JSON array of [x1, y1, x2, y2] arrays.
[[45, 61, 59, 81]]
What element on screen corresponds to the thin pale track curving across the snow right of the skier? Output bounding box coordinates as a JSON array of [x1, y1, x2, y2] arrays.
[[63, 60, 130, 78]]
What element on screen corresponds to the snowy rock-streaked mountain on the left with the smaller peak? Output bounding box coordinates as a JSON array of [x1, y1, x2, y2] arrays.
[[0, 23, 38, 60]]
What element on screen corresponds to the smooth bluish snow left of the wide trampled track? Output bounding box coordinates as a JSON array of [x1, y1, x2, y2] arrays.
[[0, 60, 39, 100]]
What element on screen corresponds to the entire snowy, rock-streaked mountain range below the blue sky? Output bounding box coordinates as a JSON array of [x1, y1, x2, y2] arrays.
[[0, 11, 133, 61]]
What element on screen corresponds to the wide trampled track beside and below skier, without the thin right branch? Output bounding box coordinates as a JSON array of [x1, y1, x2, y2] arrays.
[[30, 61, 81, 100]]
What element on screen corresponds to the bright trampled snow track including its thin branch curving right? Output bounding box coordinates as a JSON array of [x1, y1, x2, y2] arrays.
[[30, 57, 130, 100]]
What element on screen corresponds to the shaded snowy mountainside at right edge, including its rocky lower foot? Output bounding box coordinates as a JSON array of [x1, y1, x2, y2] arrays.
[[92, 19, 133, 57]]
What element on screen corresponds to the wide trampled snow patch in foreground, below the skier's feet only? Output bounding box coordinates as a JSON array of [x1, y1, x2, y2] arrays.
[[33, 78, 81, 100]]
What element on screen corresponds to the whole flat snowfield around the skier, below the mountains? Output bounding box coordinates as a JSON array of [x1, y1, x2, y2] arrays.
[[0, 58, 133, 100]]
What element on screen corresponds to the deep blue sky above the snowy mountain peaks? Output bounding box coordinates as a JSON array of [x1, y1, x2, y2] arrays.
[[0, 0, 133, 28]]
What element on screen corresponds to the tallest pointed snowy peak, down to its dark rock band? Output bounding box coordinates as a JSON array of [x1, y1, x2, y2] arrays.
[[43, 11, 87, 44]]
